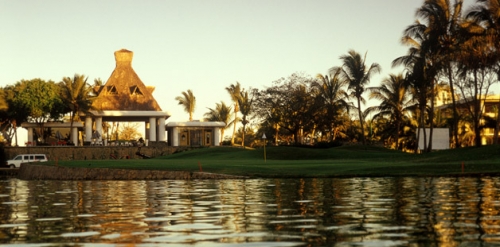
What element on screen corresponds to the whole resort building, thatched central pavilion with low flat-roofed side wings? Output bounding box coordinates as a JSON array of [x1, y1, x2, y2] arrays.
[[21, 49, 225, 146]]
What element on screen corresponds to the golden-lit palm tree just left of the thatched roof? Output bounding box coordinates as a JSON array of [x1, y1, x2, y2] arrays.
[[60, 74, 94, 144]]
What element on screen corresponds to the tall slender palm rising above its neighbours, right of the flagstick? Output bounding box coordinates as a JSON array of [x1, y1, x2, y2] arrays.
[[331, 50, 381, 145]]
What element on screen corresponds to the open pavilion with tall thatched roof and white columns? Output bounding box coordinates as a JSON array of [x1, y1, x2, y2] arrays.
[[81, 49, 170, 143]]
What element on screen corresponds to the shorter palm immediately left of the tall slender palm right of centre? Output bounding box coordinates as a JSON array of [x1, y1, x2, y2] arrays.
[[314, 69, 349, 141]]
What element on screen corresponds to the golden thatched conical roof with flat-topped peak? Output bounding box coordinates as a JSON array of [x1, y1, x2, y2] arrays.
[[92, 49, 161, 111]]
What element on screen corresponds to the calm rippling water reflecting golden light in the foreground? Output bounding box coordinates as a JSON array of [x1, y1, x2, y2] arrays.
[[0, 177, 500, 247]]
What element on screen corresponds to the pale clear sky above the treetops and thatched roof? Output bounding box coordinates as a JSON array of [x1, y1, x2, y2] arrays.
[[0, 0, 472, 125]]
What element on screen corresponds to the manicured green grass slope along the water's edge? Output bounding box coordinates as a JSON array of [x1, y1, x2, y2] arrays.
[[49, 145, 500, 177]]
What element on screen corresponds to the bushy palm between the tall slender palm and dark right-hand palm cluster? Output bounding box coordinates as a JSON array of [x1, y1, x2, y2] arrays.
[[366, 74, 415, 150]]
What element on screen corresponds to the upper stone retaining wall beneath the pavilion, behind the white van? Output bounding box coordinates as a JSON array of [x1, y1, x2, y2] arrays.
[[5, 145, 189, 160]]
